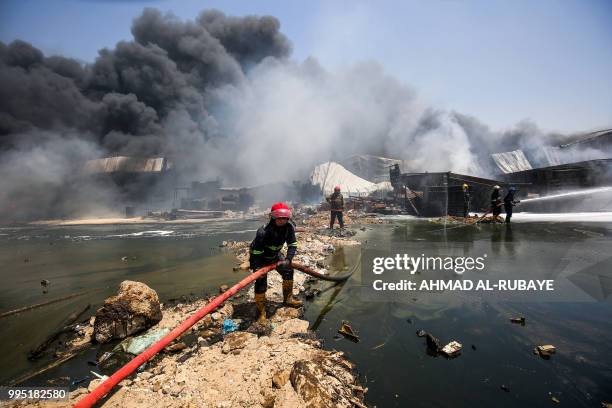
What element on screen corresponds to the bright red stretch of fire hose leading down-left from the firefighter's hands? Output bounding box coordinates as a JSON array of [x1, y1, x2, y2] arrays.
[[74, 264, 277, 408]]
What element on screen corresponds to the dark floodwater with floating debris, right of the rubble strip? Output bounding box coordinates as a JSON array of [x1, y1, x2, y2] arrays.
[[307, 220, 612, 407]]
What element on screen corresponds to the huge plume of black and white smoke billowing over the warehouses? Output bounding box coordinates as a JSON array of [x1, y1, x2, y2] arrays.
[[0, 8, 596, 218]]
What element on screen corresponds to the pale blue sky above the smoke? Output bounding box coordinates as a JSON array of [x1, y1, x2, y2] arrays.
[[0, 0, 612, 132]]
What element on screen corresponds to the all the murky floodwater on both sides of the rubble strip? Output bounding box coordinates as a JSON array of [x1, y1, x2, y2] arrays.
[[0, 217, 612, 407]]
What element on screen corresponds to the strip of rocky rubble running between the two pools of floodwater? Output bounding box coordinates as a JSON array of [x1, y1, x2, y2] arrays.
[[15, 214, 378, 407]]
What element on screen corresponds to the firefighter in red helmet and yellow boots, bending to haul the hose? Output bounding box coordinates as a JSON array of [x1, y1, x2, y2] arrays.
[[249, 203, 302, 323]]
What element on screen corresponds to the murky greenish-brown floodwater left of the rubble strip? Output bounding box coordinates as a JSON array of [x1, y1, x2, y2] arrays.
[[0, 221, 261, 384]]
